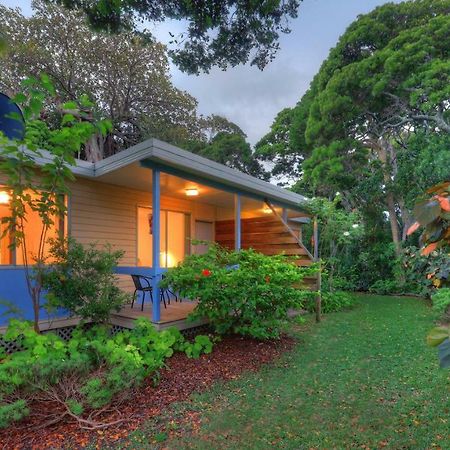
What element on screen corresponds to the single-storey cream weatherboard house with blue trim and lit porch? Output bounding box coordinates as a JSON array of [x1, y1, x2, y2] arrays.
[[0, 139, 313, 328]]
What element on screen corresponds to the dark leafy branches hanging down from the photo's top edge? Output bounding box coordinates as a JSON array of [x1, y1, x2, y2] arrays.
[[48, 0, 301, 73]]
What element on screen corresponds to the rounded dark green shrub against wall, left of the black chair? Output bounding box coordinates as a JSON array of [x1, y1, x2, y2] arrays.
[[42, 239, 128, 323]]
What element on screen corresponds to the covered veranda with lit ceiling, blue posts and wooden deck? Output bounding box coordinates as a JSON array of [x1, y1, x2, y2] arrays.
[[87, 139, 313, 328]]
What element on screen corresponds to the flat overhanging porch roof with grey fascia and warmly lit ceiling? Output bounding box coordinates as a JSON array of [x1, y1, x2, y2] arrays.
[[30, 139, 306, 211]]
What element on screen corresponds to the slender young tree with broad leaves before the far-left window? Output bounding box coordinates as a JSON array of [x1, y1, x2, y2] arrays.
[[0, 75, 109, 330]]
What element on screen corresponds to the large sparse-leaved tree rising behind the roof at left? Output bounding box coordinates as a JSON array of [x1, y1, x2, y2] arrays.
[[0, 0, 200, 161]]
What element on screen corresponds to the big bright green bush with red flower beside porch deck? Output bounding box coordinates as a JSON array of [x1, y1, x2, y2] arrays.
[[162, 245, 312, 339]]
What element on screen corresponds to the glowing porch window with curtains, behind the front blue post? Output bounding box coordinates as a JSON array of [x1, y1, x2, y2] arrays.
[[137, 207, 189, 267]]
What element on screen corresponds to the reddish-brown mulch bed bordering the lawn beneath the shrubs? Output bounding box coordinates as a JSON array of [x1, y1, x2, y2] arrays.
[[0, 336, 295, 450]]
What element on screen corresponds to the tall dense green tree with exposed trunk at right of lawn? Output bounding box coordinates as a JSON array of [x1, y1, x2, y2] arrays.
[[260, 0, 450, 254]]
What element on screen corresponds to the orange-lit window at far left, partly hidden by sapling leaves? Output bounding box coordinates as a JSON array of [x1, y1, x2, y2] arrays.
[[0, 186, 64, 265]]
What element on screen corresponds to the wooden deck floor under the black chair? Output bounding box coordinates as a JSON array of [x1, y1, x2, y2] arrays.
[[111, 300, 207, 330]]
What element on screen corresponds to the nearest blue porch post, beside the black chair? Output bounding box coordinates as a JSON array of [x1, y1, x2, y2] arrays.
[[152, 169, 161, 322]]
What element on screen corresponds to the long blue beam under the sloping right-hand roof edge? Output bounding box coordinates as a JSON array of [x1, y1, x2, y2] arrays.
[[140, 159, 303, 211]]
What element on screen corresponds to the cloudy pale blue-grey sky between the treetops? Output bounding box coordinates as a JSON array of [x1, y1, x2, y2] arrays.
[[0, 0, 400, 144]]
